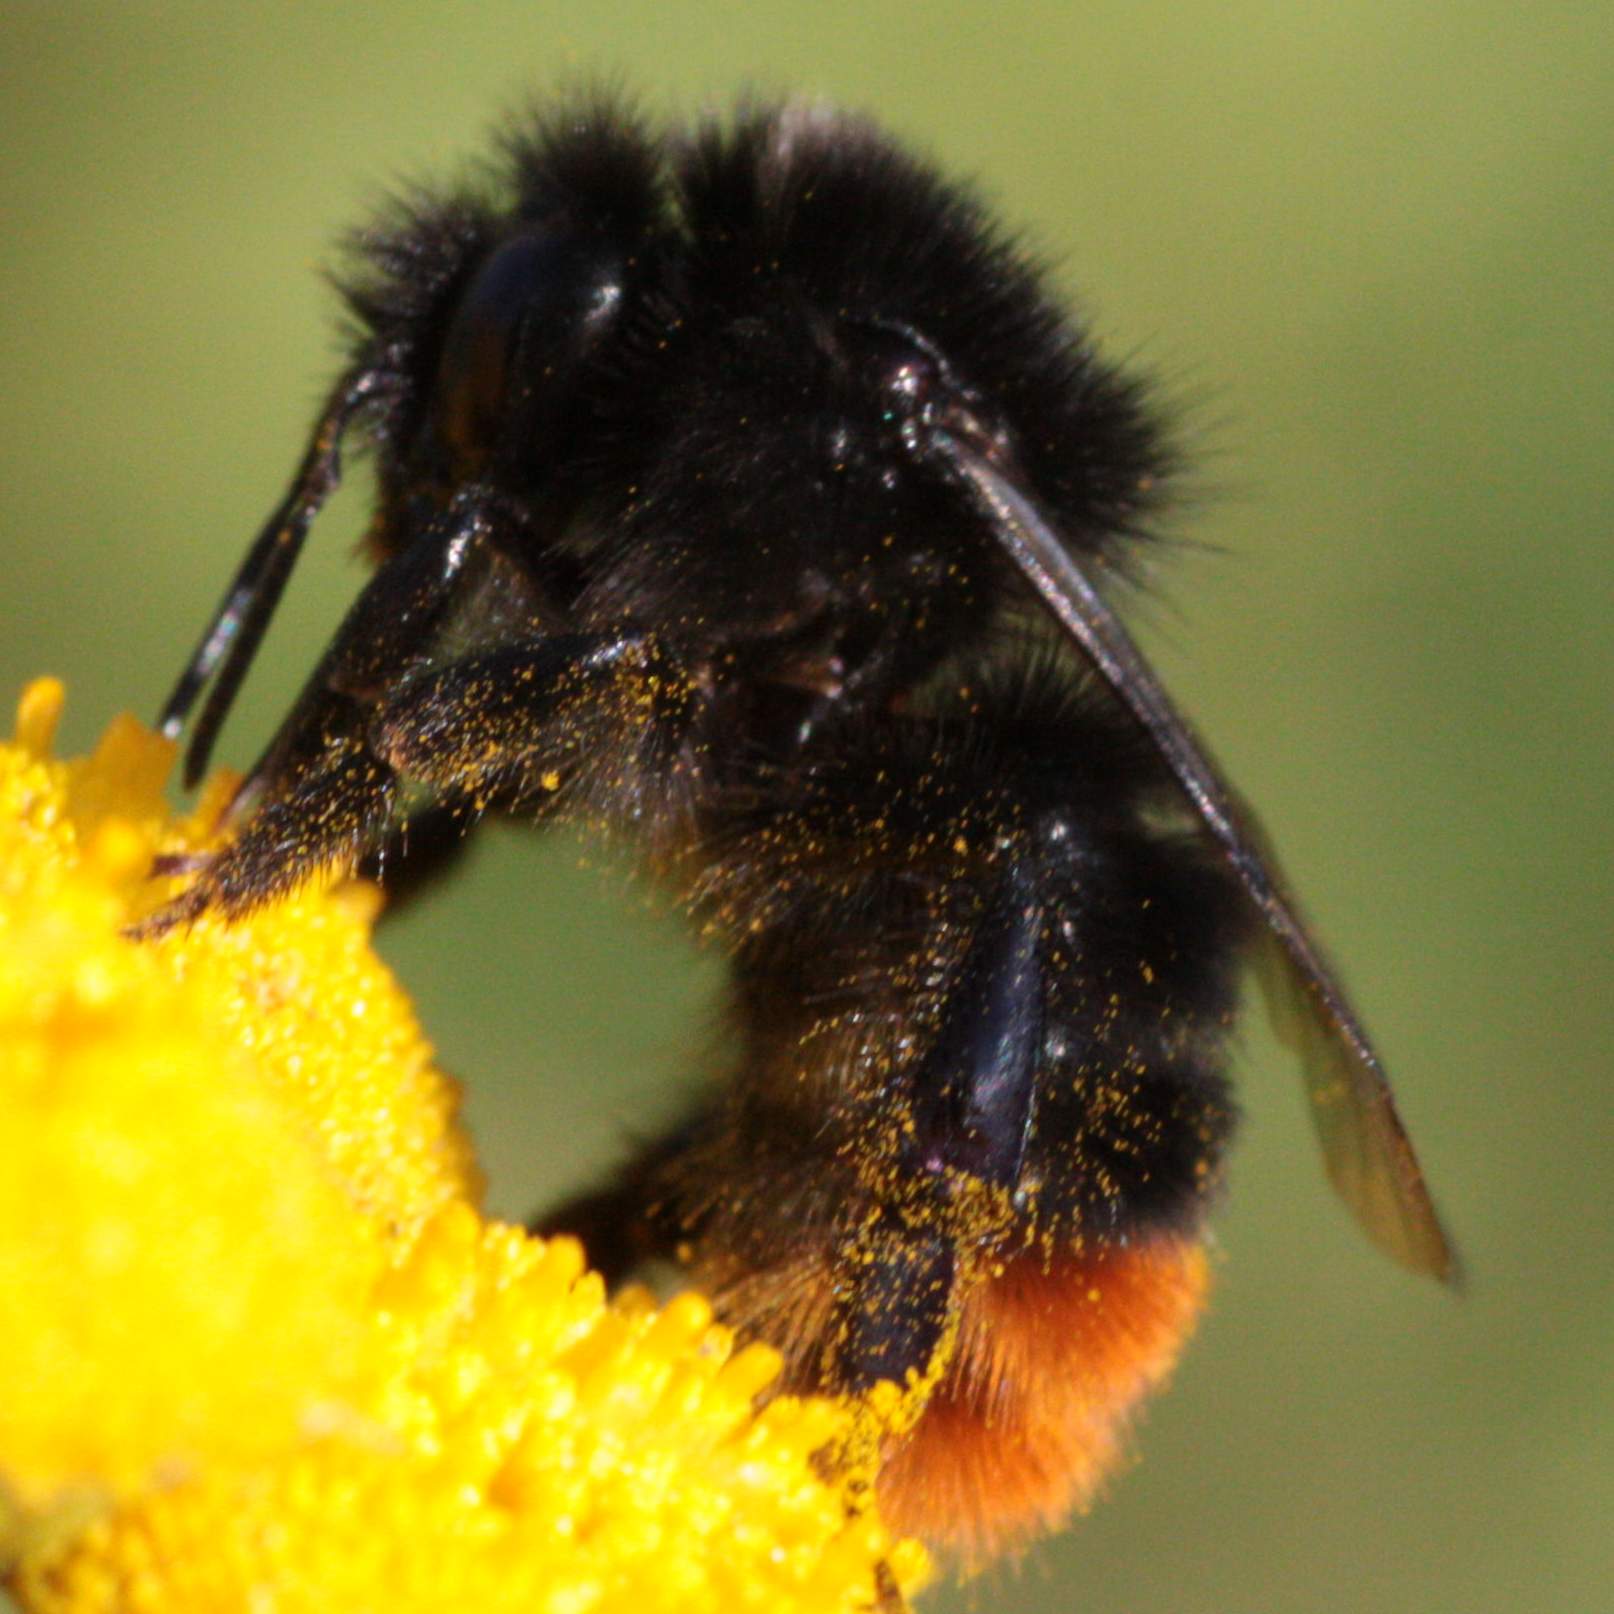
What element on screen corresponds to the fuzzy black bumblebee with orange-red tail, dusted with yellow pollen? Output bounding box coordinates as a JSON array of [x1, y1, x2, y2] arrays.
[[148, 100, 1454, 1558]]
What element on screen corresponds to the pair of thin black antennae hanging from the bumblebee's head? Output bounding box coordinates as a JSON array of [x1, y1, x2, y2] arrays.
[[157, 363, 379, 789]]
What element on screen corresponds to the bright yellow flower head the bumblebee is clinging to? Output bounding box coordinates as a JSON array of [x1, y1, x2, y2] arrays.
[[0, 681, 926, 1614]]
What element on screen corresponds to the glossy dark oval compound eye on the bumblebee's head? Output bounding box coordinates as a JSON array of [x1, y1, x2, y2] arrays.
[[436, 224, 625, 468]]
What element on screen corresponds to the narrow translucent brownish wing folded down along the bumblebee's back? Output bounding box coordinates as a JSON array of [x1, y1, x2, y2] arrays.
[[933, 431, 1457, 1282]]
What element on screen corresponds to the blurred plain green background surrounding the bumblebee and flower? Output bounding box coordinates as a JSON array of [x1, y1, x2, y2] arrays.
[[0, 0, 1614, 1614]]
